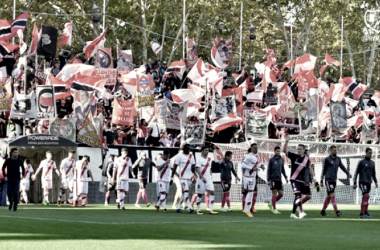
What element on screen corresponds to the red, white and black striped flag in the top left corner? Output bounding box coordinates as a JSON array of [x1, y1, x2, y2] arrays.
[[0, 11, 29, 42]]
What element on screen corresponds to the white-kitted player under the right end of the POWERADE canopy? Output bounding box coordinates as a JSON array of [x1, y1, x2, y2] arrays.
[[57, 150, 75, 207]]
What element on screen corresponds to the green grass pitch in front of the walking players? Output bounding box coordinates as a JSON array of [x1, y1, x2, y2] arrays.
[[0, 203, 380, 250]]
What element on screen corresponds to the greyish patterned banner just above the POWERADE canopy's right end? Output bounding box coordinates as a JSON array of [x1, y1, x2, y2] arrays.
[[49, 118, 76, 142]]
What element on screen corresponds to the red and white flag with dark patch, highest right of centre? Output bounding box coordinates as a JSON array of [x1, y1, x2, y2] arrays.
[[211, 37, 232, 69]]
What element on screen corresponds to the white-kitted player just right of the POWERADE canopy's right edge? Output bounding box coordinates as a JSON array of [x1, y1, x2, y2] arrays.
[[71, 155, 94, 207]]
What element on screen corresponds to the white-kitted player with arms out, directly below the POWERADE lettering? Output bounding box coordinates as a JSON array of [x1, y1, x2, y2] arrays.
[[32, 151, 60, 205]]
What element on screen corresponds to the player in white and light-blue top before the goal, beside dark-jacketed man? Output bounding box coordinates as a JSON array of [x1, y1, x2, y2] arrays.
[[241, 143, 265, 217]]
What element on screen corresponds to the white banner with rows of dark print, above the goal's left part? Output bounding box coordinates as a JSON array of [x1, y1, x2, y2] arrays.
[[244, 109, 268, 138]]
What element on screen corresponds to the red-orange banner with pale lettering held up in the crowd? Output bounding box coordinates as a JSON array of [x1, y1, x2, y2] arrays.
[[112, 98, 135, 126]]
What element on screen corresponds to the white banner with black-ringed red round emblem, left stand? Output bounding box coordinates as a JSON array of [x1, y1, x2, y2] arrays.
[[36, 85, 57, 119]]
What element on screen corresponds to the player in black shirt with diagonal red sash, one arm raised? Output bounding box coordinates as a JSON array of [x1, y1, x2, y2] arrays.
[[283, 135, 314, 219]]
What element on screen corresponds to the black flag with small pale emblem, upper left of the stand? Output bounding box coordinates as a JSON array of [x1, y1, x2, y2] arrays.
[[37, 25, 58, 58]]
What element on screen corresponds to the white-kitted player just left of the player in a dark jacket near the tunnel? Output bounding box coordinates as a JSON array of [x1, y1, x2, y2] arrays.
[[112, 148, 135, 210]]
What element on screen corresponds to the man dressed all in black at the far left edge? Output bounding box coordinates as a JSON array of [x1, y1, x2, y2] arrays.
[[2, 148, 25, 212]]
